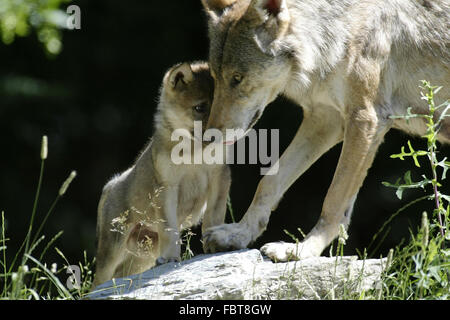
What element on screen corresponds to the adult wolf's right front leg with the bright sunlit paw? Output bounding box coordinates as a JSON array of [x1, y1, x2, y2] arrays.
[[261, 107, 391, 261]]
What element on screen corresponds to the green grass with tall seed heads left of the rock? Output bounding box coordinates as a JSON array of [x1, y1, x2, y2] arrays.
[[0, 136, 93, 300]]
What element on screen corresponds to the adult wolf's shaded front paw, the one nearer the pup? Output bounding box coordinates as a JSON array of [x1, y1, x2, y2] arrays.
[[203, 223, 252, 253]]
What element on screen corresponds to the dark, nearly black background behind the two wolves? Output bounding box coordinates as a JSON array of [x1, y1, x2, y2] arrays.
[[0, 0, 450, 272]]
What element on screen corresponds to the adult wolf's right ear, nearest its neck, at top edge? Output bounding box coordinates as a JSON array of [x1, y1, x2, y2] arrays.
[[245, 0, 291, 52]]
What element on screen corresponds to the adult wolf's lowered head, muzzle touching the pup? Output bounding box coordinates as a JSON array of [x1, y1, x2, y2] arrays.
[[202, 0, 291, 142]]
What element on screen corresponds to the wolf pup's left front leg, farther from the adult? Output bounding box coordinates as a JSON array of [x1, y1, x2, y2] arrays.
[[156, 187, 181, 265]]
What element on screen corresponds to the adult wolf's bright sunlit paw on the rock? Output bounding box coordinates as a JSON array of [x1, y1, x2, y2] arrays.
[[260, 241, 317, 262]]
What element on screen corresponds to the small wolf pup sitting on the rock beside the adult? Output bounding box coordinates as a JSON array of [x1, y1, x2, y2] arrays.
[[94, 62, 231, 285]]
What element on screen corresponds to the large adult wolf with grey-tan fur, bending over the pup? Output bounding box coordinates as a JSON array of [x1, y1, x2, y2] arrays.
[[202, 0, 450, 261]]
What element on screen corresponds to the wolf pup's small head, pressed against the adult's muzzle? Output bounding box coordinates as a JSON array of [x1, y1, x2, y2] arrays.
[[156, 62, 214, 135]]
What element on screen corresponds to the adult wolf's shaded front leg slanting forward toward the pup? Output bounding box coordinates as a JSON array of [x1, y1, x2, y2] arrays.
[[203, 106, 343, 252]]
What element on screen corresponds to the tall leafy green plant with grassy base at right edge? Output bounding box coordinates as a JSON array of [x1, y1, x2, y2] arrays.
[[383, 81, 450, 299]]
